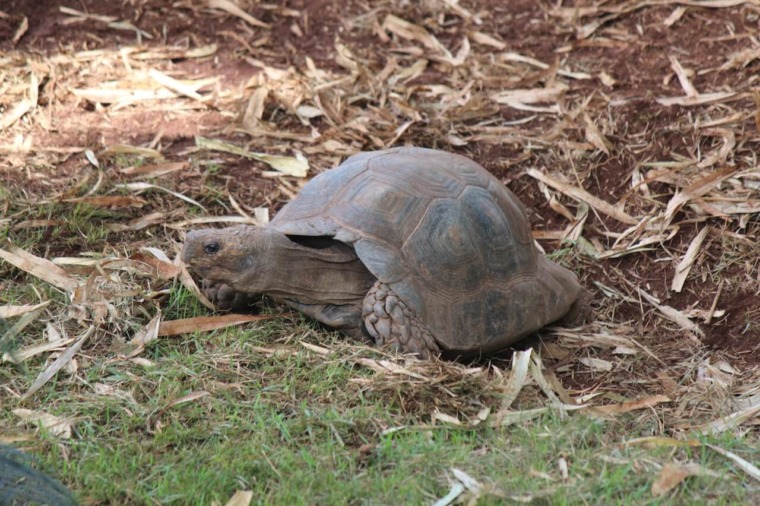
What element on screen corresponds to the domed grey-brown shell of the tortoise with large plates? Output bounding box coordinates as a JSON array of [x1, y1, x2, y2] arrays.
[[269, 148, 581, 352]]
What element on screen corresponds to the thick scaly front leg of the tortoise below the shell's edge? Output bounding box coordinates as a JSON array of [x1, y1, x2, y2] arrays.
[[362, 281, 441, 358]]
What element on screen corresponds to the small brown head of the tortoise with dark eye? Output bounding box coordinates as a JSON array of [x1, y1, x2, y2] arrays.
[[182, 226, 269, 287]]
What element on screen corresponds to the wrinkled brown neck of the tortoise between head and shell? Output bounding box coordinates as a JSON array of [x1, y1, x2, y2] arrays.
[[225, 227, 374, 305]]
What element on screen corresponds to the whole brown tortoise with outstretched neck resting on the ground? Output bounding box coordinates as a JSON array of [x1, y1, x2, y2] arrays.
[[182, 147, 588, 357]]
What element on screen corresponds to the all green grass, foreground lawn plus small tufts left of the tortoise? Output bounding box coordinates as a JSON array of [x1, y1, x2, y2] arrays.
[[0, 183, 760, 505]]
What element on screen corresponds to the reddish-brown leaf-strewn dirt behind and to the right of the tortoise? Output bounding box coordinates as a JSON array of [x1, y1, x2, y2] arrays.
[[0, 0, 760, 426]]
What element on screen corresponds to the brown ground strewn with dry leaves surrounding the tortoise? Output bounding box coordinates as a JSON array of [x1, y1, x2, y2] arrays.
[[0, 0, 760, 504]]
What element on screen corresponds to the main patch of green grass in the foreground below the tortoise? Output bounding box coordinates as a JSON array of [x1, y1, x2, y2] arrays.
[[0, 314, 760, 504]]
